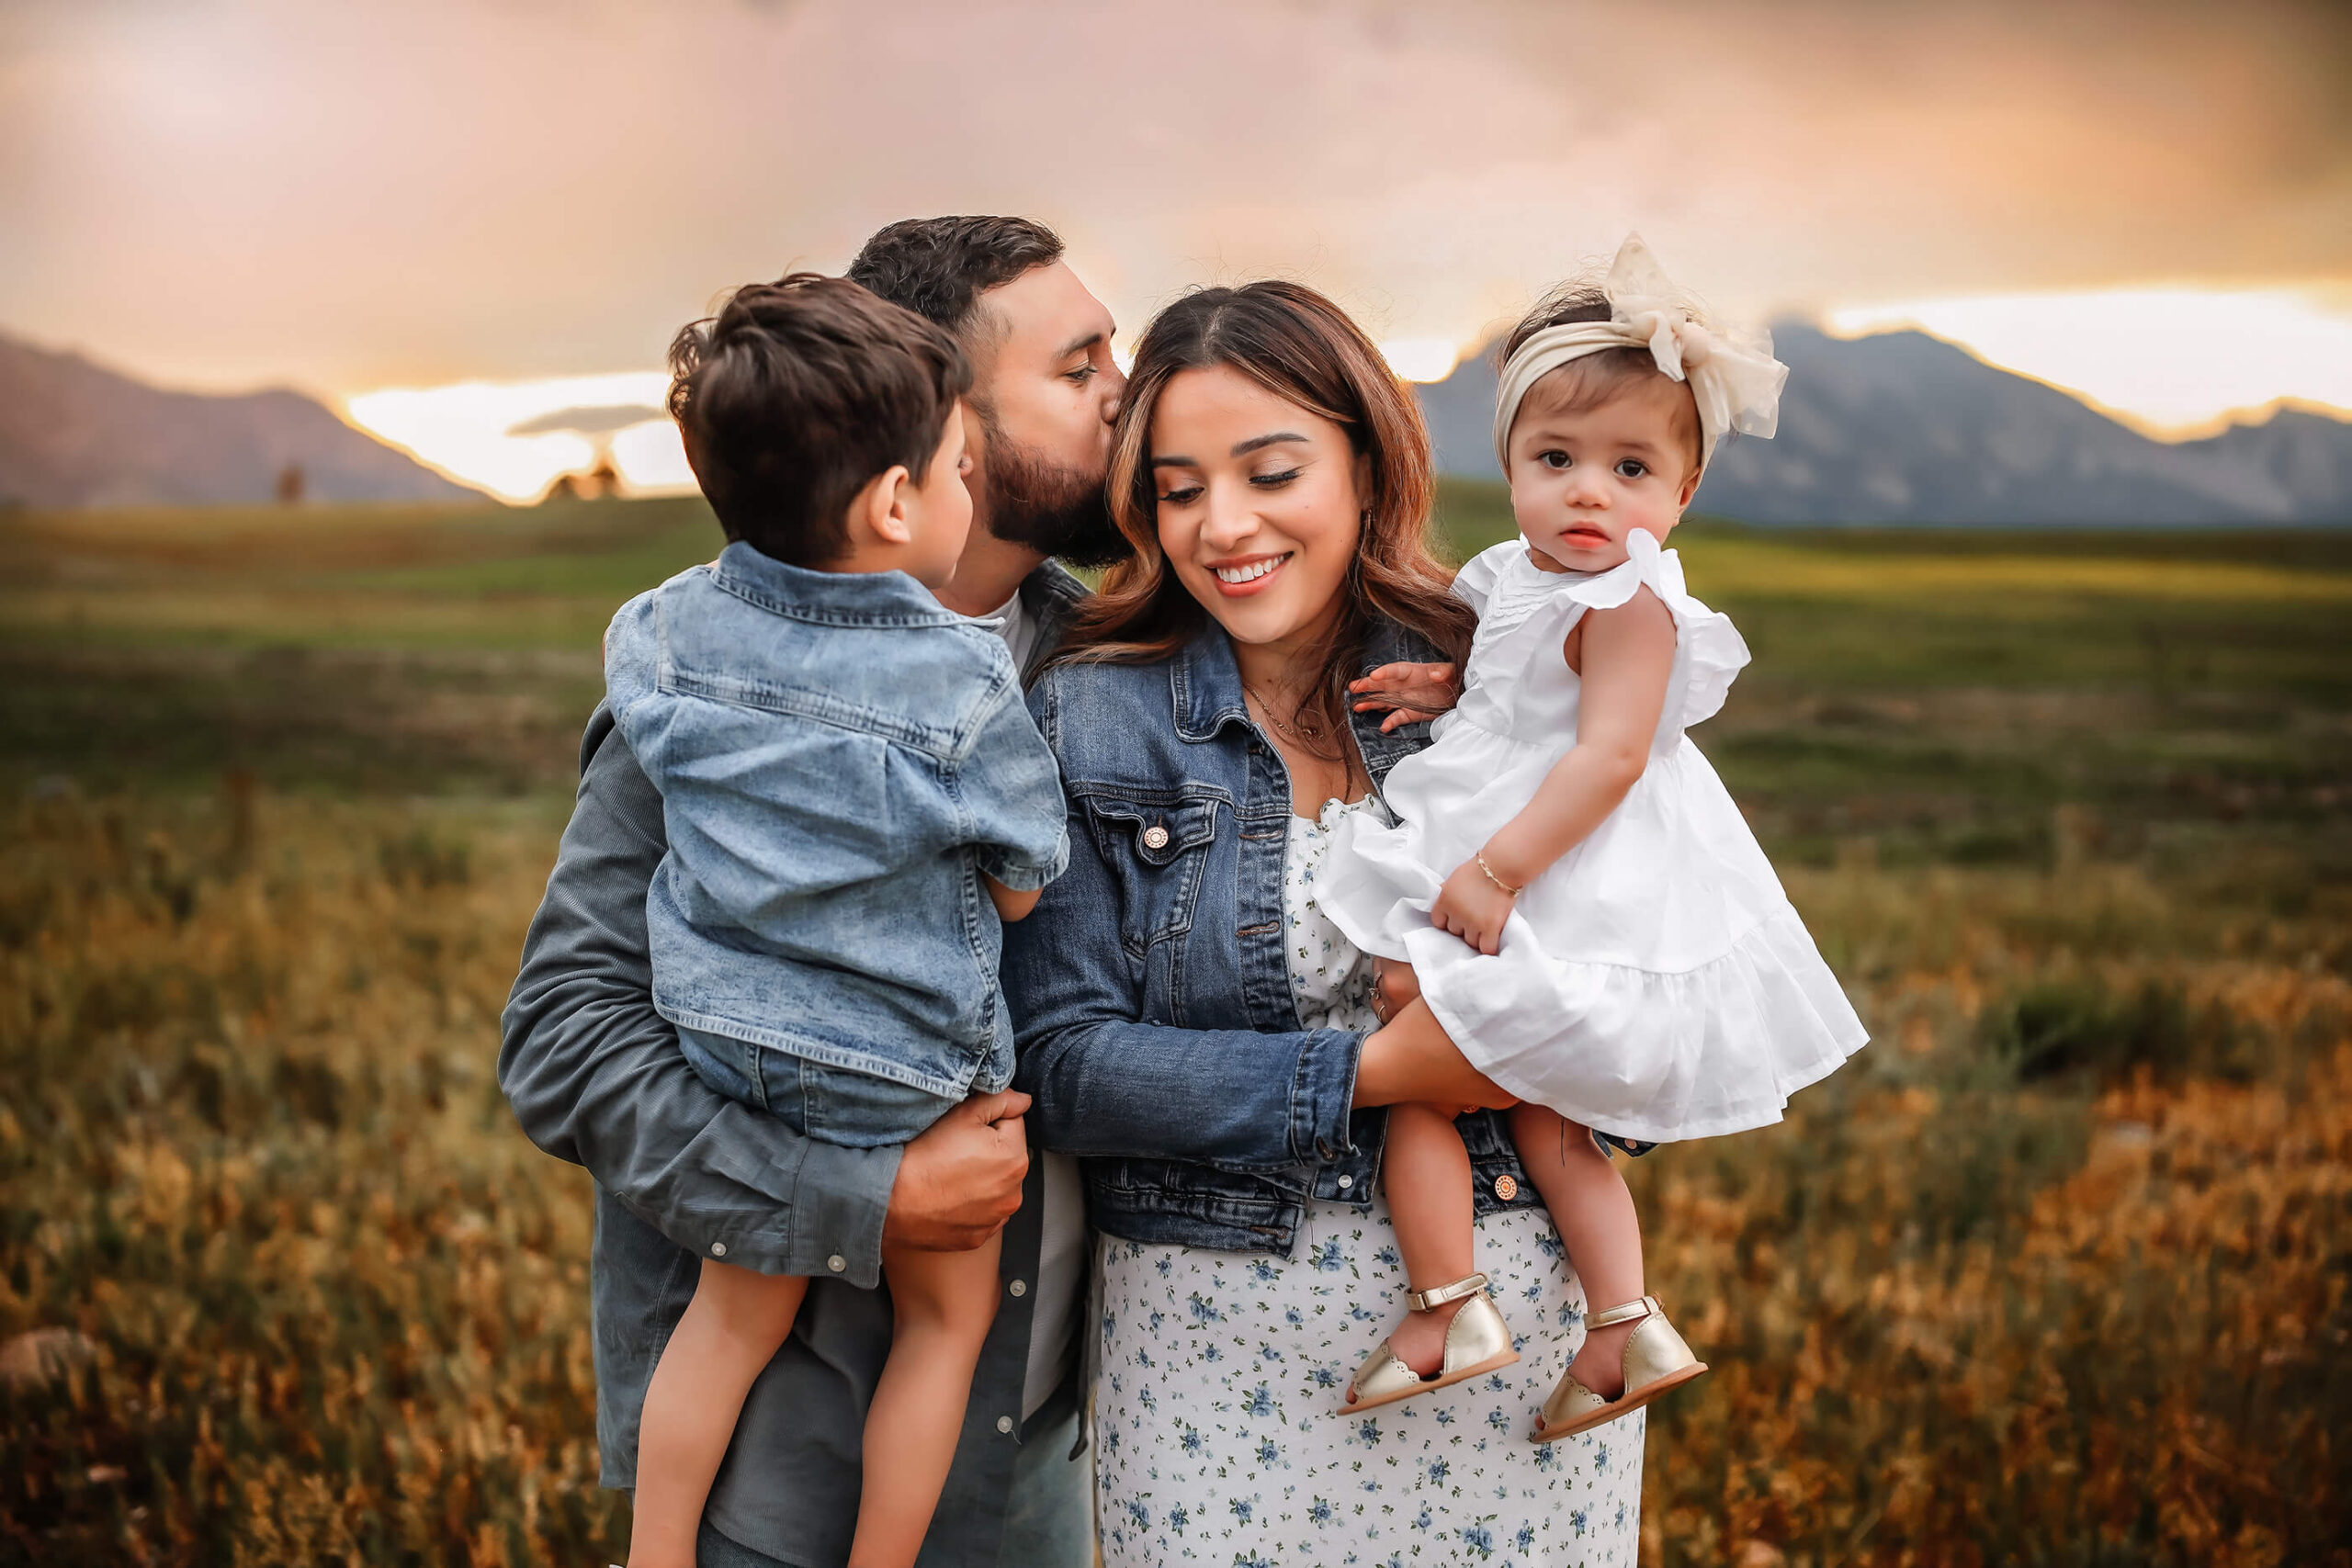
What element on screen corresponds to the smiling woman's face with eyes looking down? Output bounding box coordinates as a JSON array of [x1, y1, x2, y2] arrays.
[[1150, 367, 1369, 644]]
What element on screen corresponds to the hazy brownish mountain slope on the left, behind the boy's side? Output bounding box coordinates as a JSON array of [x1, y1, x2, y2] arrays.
[[0, 336, 482, 508]]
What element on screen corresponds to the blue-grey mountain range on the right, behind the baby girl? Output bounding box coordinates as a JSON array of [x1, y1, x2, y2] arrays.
[[1419, 322, 2352, 525]]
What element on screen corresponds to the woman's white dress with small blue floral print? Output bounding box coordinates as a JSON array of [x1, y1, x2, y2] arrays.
[[1093, 802, 1644, 1568]]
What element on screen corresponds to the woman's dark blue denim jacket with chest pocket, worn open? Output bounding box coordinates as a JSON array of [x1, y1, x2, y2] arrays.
[[1004, 626, 1538, 1253]]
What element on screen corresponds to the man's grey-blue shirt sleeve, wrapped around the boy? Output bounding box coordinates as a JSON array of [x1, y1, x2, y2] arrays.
[[499, 707, 899, 1286]]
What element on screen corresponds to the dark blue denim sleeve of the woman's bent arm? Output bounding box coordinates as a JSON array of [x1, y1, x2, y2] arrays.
[[1004, 682, 1383, 1168]]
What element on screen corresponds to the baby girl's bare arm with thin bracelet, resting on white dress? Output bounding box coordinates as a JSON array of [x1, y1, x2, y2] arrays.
[[1430, 588, 1675, 952]]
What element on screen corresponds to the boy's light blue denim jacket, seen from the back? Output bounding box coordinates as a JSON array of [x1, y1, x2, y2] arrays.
[[605, 543, 1068, 1098]]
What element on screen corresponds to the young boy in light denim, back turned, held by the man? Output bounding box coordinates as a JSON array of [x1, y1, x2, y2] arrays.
[[605, 273, 1068, 1568]]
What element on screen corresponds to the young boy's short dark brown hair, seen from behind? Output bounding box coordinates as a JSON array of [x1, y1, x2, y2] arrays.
[[671, 273, 971, 567]]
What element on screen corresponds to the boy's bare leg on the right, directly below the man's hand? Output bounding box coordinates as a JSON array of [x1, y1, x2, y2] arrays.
[[851, 1236, 1004, 1568]]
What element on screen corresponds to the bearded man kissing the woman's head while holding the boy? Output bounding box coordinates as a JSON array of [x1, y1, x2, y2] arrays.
[[499, 219, 1125, 1568]]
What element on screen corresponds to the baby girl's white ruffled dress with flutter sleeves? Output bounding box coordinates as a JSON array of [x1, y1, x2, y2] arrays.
[[1322, 529, 1868, 1143]]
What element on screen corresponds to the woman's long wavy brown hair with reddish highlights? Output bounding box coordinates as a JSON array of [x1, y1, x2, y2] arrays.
[[1058, 282, 1475, 748]]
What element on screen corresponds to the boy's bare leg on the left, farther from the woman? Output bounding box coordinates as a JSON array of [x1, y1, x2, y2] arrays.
[[628, 1258, 809, 1568]]
